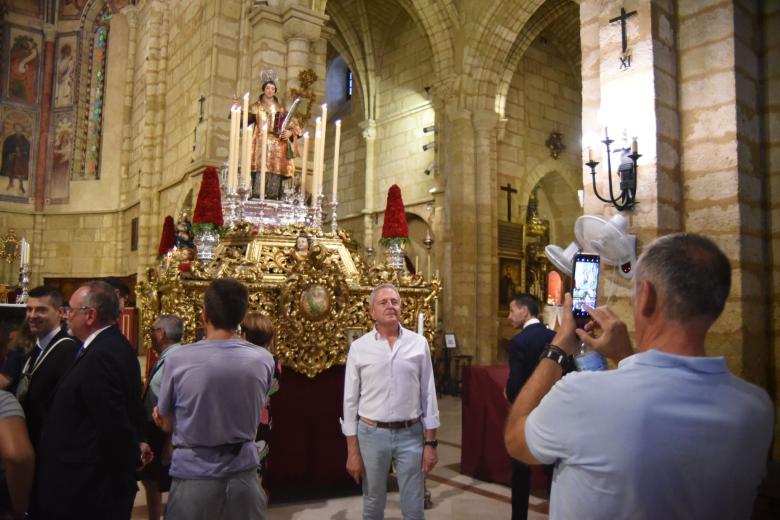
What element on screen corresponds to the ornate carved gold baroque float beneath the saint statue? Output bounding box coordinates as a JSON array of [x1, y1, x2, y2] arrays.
[[136, 223, 441, 377]]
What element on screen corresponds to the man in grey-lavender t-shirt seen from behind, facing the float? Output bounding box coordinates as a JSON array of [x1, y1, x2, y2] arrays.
[[154, 278, 274, 520]]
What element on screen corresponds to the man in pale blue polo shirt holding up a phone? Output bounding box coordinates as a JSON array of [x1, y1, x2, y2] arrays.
[[505, 233, 773, 520]]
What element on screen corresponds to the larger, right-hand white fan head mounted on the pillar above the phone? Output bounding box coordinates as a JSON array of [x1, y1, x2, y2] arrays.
[[569, 213, 636, 278]]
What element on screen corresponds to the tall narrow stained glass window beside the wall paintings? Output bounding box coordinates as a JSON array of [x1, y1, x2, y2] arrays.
[[83, 14, 111, 179]]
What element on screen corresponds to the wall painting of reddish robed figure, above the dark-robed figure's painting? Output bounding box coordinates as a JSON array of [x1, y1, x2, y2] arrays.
[[4, 28, 43, 105]]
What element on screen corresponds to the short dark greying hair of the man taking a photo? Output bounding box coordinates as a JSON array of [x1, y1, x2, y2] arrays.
[[635, 233, 731, 322]]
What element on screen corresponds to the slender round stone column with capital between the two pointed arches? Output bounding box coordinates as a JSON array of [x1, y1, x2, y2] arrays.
[[472, 110, 498, 365]]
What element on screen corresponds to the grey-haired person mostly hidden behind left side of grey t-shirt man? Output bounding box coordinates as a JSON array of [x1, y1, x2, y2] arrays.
[[139, 314, 184, 520]]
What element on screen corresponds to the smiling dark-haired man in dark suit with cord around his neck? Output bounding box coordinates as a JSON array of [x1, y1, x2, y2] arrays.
[[16, 286, 80, 448]]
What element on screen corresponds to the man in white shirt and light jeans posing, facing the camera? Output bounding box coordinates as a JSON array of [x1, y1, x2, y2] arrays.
[[341, 284, 439, 520]]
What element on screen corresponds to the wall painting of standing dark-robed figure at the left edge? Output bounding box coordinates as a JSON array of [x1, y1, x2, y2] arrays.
[[0, 110, 36, 203]]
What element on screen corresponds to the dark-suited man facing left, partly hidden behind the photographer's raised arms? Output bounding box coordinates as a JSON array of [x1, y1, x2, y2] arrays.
[[506, 294, 555, 520]]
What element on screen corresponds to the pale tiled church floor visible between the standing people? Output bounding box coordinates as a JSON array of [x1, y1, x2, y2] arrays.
[[133, 396, 547, 520]]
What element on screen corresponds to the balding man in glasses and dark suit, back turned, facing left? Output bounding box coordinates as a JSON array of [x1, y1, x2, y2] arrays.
[[34, 281, 151, 520]]
